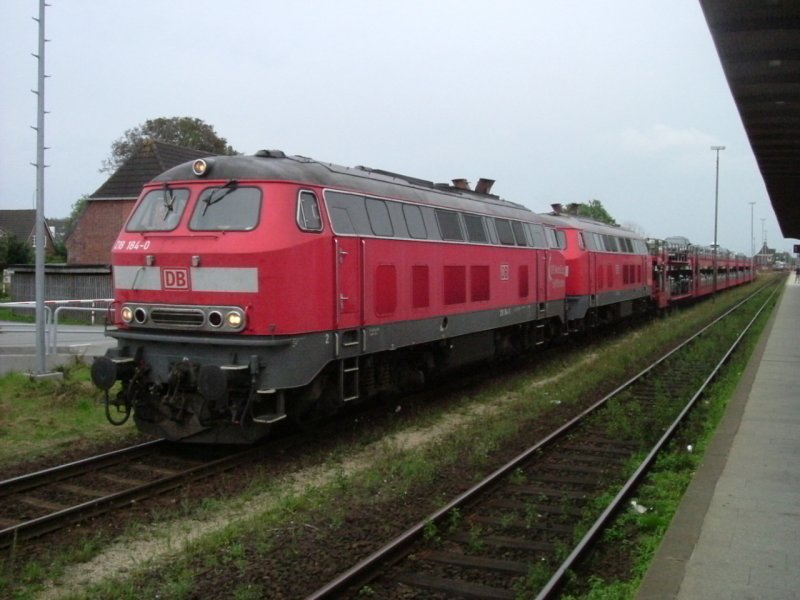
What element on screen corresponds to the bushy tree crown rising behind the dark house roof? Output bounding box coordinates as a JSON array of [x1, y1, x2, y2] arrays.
[[100, 117, 238, 173]]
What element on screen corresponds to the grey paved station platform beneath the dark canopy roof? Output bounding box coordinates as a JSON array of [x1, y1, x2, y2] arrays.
[[637, 275, 800, 600]]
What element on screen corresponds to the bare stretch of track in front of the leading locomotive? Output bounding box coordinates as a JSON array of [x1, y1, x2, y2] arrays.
[[0, 440, 260, 548]]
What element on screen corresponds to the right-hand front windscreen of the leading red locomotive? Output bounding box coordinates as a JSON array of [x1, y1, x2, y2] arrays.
[[189, 186, 261, 231]]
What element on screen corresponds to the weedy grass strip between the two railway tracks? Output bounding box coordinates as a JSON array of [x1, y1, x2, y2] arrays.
[[0, 274, 784, 599]]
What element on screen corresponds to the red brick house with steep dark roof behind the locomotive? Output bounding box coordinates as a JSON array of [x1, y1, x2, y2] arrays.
[[66, 140, 209, 265]]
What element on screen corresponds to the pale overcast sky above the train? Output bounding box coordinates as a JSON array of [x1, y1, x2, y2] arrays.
[[0, 0, 793, 253]]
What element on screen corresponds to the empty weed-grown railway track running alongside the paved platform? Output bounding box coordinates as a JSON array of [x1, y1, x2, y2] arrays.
[[307, 287, 777, 600]]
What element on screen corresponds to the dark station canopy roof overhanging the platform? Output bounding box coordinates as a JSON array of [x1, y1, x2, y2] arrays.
[[700, 0, 800, 238]]
